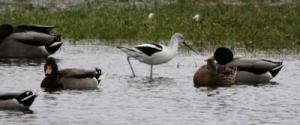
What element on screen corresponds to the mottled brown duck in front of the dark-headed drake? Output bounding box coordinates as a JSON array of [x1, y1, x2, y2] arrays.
[[193, 56, 237, 88]]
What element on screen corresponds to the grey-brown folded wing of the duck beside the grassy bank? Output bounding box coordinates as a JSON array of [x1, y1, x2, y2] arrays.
[[9, 31, 56, 46]]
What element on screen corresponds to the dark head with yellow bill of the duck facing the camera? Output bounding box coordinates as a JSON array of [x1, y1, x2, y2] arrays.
[[44, 57, 58, 76]]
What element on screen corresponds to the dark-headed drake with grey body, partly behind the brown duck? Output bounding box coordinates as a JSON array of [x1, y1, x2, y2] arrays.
[[210, 47, 283, 83]]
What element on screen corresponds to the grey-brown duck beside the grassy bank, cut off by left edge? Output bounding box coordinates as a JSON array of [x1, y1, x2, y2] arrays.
[[0, 24, 63, 58]]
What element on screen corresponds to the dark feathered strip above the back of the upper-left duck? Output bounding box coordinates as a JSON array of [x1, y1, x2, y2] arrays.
[[15, 25, 55, 34]]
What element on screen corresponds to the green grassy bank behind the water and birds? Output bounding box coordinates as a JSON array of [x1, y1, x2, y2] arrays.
[[0, 2, 300, 50]]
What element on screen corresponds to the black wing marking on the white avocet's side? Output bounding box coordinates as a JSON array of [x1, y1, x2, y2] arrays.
[[135, 44, 163, 56]]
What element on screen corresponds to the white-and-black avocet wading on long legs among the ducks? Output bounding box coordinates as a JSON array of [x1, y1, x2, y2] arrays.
[[117, 33, 195, 79]]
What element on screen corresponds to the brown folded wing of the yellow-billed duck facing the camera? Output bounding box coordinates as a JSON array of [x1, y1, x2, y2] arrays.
[[59, 68, 96, 78]]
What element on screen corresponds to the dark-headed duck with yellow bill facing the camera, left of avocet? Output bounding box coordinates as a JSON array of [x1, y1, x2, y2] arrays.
[[41, 57, 104, 91]]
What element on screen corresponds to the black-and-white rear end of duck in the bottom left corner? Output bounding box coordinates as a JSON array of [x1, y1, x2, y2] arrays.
[[0, 91, 37, 110]]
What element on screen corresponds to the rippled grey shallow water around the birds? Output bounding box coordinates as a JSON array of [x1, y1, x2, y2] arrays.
[[0, 44, 300, 125]]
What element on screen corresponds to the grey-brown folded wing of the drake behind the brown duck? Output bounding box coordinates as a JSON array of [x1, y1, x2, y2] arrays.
[[229, 58, 282, 74]]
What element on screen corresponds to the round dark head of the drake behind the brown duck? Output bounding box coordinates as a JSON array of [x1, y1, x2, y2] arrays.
[[213, 47, 233, 65]]
